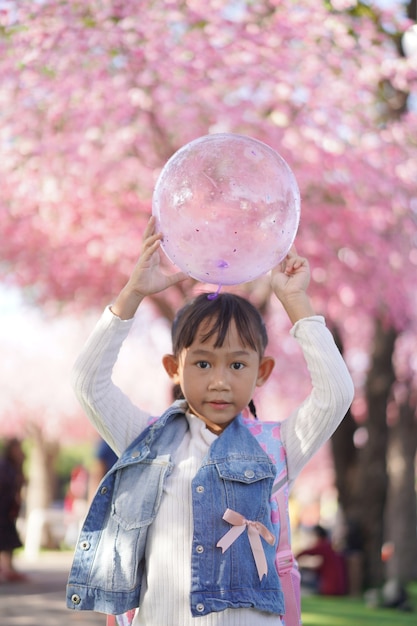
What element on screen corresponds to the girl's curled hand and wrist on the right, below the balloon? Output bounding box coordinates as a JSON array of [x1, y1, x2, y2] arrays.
[[271, 246, 315, 323]]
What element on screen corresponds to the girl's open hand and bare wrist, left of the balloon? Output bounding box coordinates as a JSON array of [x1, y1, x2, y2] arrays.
[[111, 216, 188, 319]]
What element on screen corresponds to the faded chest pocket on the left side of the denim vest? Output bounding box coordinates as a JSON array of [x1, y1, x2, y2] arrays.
[[112, 454, 173, 530]]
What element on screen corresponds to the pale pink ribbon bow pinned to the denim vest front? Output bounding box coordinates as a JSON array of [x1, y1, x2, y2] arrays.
[[217, 509, 275, 580]]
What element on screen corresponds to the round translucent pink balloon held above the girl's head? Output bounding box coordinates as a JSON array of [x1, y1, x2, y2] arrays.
[[152, 133, 300, 285]]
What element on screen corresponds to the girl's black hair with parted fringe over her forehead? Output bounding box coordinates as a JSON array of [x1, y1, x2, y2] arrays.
[[171, 292, 268, 418]]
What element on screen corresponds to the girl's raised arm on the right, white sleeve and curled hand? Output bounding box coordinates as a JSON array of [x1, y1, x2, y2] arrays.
[[271, 246, 353, 483]]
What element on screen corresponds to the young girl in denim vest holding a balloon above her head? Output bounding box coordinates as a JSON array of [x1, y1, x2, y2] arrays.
[[67, 218, 353, 626]]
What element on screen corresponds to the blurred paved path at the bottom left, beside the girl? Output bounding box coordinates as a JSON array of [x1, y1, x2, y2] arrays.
[[0, 551, 106, 626]]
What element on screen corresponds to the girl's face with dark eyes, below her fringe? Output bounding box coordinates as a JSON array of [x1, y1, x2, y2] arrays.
[[163, 323, 274, 433]]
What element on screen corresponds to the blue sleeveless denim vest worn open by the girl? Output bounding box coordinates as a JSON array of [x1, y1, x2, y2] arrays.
[[67, 406, 286, 616]]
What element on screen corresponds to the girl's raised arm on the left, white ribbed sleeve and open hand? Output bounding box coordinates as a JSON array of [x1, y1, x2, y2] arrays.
[[72, 217, 187, 454]]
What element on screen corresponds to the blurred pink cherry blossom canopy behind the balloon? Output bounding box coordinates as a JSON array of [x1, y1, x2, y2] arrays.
[[0, 0, 417, 316]]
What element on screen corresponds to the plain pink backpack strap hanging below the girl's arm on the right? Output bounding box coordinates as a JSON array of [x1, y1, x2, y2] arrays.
[[272, 476, 301, 626]]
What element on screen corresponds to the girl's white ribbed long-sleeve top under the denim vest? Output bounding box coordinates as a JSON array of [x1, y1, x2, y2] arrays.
[[73, 308, 353, 626]]
